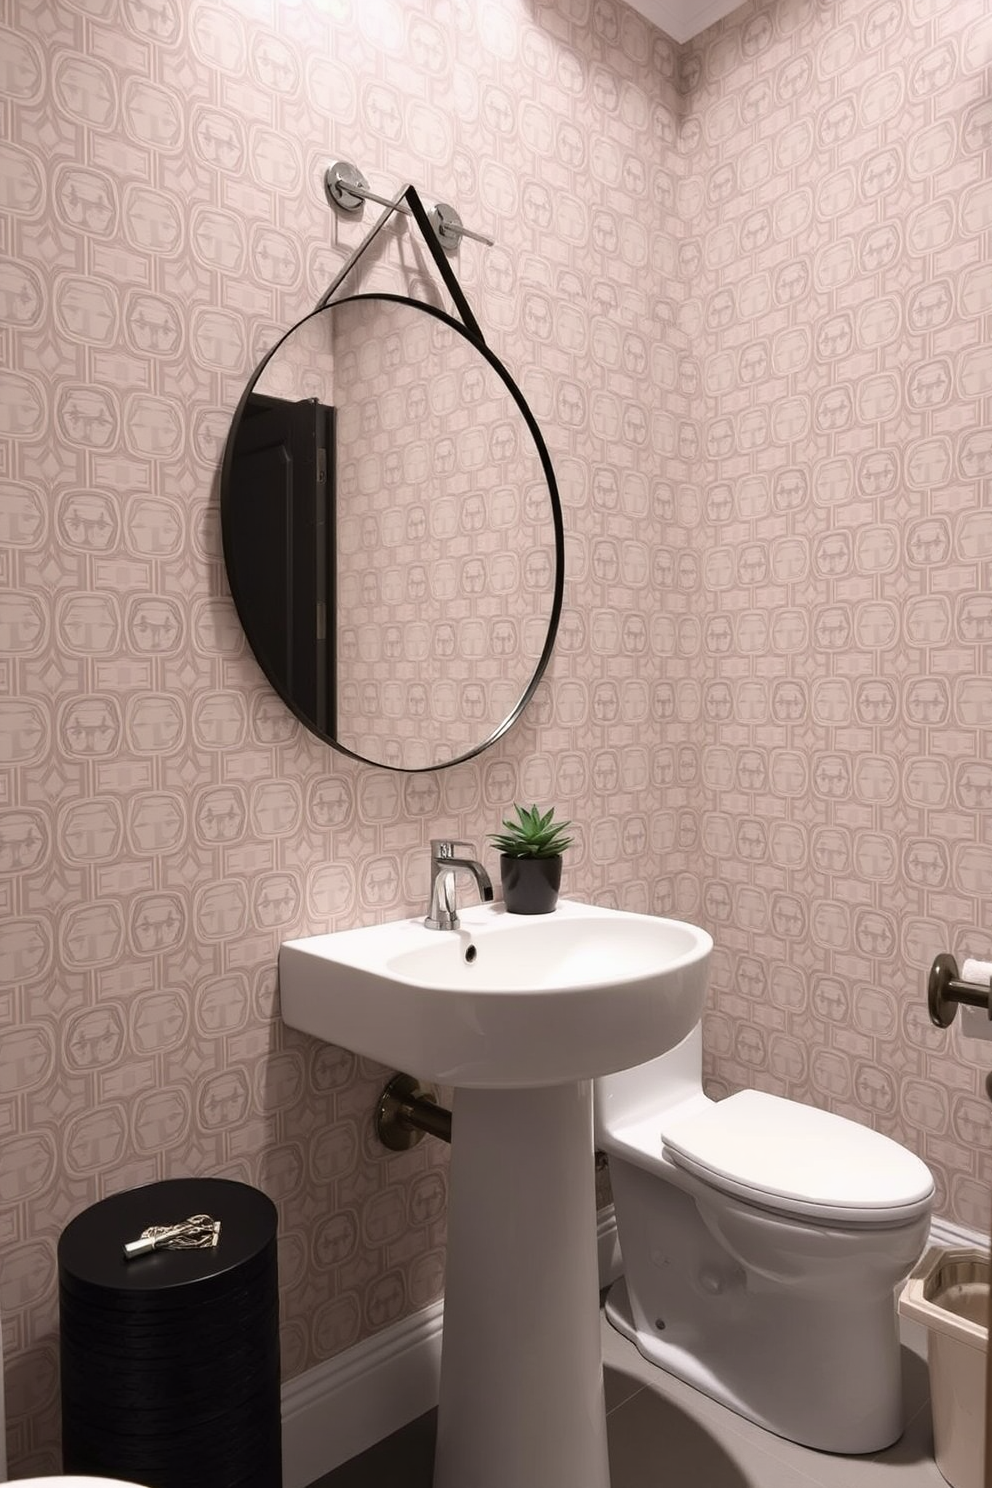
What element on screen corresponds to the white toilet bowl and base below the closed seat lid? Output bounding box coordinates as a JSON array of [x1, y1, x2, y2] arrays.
[[607, 1140, 930, 1457]]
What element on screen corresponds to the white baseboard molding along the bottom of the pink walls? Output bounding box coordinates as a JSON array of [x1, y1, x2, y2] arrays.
[[283, 1204, 989, 1488]]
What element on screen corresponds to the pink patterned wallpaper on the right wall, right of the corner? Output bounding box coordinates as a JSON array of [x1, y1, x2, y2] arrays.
[[687, 0, 992, 1231]]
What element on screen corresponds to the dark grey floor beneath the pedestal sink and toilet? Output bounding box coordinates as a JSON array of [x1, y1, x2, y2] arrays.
[[312, 1317, 947, 1488]]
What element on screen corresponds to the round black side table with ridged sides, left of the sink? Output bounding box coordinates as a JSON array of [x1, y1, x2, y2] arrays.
[[58, 1178, 283, 1488]]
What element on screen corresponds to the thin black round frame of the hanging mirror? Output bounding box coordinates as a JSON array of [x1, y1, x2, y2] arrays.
[[220, 293, 565, 775]]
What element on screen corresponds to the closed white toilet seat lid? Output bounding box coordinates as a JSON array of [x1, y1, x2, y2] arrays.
[[662, 1091, 934, 1225]]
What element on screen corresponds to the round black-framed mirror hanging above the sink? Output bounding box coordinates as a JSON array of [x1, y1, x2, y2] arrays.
[[220, 295, 564, 771]]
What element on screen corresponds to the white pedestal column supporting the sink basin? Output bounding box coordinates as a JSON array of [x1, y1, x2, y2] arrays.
[[434, 1080, 610, 1488]]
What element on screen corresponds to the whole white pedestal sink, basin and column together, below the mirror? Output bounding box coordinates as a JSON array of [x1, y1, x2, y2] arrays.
[[280, 900, 712, 1488]]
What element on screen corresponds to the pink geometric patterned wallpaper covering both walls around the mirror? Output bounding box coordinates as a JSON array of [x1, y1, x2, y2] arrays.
[[0, 0, 992, 1475]]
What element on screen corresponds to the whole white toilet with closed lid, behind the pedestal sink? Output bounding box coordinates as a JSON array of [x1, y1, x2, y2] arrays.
[[595, 1024, 934, 1452]]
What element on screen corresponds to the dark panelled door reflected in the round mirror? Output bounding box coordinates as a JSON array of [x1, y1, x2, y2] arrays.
[[228, 393, 335, 734]]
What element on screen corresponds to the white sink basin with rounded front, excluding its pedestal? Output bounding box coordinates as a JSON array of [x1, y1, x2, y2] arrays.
[[280, 900, 712, 1089]]
